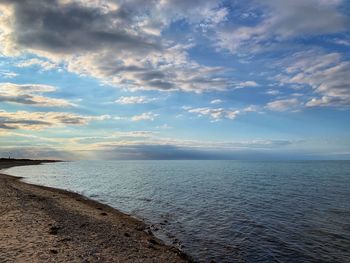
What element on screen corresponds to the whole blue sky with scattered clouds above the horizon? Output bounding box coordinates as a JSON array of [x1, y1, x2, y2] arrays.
[[0, 0, 350, 160]]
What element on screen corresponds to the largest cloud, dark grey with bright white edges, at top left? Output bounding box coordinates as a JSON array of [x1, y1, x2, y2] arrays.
[[0, 0, 232, 92]]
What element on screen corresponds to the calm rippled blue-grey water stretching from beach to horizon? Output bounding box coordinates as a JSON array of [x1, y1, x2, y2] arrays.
[[7, 161, 350, 262]]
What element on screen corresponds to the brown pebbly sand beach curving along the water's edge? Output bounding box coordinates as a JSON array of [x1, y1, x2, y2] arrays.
[[0, 160, 191, 262]]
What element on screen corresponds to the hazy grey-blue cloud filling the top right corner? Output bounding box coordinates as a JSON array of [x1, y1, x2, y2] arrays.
[[217, 0, 349, 53]]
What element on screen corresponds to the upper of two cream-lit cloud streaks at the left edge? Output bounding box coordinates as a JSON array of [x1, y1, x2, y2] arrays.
[[0, 83, 75, 107]]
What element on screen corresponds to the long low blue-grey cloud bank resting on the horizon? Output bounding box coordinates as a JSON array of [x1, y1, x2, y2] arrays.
[[82, 138, 308, 160]]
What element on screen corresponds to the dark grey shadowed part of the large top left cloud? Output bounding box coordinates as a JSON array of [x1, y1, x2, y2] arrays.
[[1, 0, 159, 54]]
